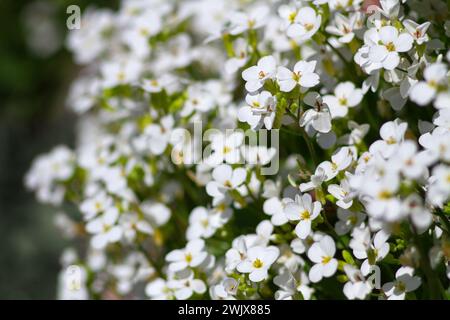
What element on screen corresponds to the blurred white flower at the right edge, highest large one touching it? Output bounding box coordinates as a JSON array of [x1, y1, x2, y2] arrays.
[[409, 63, 448, 106]]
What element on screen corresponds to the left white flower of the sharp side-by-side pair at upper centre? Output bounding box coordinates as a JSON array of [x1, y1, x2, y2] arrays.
[[242, 56, 277, 92]]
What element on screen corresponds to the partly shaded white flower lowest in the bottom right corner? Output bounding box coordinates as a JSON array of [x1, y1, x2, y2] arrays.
[[382, 267, 422, 300]]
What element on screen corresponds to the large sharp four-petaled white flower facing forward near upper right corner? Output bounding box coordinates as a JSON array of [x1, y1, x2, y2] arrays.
[[364, 26, 413, 70]]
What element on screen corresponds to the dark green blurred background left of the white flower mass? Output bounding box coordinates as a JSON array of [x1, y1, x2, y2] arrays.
[[0, 0, 118, 299]]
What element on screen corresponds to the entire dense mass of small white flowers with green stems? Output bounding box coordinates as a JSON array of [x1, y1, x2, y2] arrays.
[[25, 0, 450, 300]]
